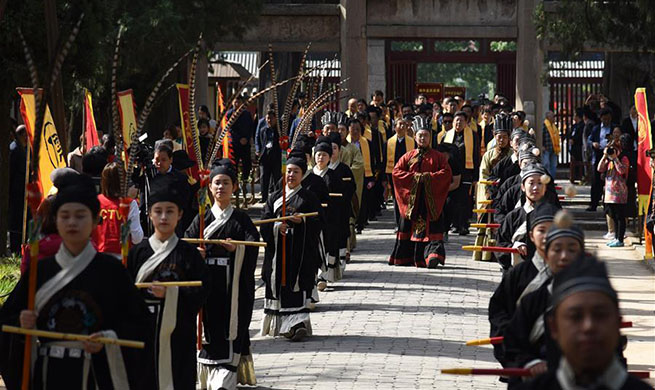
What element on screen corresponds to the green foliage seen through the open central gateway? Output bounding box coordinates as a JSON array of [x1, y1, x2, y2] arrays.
[[416, 63, 496, 98]]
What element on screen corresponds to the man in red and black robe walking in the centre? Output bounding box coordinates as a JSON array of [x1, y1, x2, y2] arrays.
[[389, 117, 452, 268]]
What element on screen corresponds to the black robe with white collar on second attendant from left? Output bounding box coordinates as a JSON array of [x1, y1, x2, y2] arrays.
[[127, 236, 210, 389]]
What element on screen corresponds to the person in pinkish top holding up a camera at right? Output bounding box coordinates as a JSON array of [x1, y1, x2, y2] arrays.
[[598, 131, 630, 248]]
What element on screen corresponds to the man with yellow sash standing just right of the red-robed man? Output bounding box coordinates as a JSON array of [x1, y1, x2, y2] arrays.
[[442, 111, 480, 236]]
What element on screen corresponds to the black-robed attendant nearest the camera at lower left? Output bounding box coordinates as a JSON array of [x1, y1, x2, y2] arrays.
[[0, 174, 152, 390]]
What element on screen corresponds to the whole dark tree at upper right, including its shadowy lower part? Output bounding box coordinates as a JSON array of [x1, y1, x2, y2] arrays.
[[535, 0, 655, 111]]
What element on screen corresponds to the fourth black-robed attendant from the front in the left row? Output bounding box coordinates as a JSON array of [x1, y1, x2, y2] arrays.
[[260, 157, 325, 341]]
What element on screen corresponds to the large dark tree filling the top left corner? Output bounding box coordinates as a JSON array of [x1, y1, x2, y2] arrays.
[[0, 0, 262, 254]]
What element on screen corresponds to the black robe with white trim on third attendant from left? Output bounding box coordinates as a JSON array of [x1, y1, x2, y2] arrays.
[[185, 209, 259, 386]]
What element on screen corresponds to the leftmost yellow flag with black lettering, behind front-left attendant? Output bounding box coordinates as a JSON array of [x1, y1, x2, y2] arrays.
[[18, 88, 66, 195]]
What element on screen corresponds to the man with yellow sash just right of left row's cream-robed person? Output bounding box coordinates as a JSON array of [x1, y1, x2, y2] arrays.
[[346, 119, 375, 233]]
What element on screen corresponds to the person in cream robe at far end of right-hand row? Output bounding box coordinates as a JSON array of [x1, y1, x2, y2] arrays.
[[473, 114, 512, 261]]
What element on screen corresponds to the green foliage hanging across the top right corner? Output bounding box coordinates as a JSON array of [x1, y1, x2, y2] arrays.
[[534, 0, 655, 60]]
